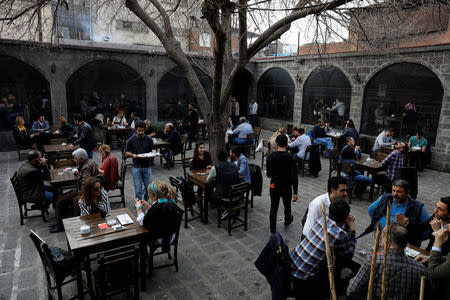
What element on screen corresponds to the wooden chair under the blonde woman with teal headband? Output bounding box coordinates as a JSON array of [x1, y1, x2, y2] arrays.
[[149, 205, 183, 276]]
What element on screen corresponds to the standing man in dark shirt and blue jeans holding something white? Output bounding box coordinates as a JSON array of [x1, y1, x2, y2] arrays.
[[125, 121, 153, 200]]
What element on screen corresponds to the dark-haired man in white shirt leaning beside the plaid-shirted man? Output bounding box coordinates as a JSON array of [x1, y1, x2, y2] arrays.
[[302, 177, 347, 240]]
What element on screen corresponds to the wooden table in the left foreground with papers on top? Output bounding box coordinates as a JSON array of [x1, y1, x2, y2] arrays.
[[63, 208, 148, 299]]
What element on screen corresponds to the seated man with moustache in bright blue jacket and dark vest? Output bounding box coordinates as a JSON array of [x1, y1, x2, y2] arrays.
[[361, 179, 430, 247]]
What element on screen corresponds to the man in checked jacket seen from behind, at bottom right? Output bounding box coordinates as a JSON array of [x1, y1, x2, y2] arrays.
[[347, 223, 430, 299]]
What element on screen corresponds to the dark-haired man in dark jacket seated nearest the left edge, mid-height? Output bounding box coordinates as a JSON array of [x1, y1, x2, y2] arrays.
[[17, 150, 53, 209]]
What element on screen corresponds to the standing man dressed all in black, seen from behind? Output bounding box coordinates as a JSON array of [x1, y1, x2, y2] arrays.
[[266, 134, 298, 234]]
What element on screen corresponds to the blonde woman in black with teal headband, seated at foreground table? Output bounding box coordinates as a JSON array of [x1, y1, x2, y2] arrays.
[[136, 182, 177, 252]]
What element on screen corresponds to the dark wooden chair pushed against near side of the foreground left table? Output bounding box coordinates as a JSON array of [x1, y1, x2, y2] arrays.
[[93, 244, 140, 300]]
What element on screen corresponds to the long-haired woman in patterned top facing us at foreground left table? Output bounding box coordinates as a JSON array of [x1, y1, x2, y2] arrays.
[[78, 177, 111, 216]]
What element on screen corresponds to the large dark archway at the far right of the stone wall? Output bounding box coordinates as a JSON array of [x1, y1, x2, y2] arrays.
[[361, 62, 444, 144]]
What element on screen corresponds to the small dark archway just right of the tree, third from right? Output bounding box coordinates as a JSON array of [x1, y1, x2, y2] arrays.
[[257, 68, 295, 120]]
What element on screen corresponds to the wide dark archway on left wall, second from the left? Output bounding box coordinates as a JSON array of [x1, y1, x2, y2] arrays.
[[66, 60, 146, 118]]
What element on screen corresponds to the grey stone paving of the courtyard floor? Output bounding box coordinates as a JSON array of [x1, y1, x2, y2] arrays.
[[0, 131, 450, 300]]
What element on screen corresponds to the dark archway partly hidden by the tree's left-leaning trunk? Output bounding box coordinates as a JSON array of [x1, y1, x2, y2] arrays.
[[158, 67, 212, 121]]
